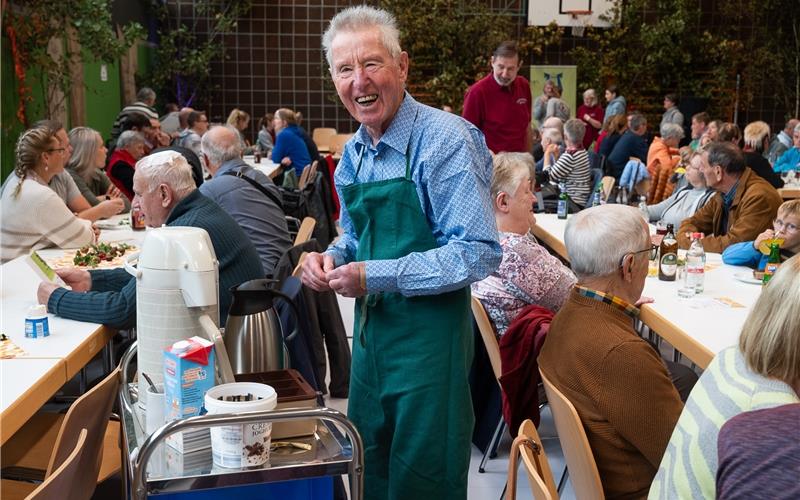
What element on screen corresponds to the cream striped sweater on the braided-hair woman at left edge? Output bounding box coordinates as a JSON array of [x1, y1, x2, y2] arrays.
[[0, 172, 94, 262]]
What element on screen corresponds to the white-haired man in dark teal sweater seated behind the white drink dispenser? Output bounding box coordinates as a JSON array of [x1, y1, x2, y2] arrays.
[[37, 151, 264, 328]]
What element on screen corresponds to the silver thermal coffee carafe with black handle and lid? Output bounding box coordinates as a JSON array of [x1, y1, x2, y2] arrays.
[[224, 279, 300, 375]]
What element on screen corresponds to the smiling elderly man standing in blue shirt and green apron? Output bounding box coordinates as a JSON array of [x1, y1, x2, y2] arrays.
[[303, 6, 502, 499]]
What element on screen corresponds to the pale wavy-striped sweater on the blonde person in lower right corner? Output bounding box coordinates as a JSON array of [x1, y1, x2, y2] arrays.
[[648, 346, 800, 499]]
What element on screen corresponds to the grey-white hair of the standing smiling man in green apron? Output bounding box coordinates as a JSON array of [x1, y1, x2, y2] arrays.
[[322, 5, 401, 70]]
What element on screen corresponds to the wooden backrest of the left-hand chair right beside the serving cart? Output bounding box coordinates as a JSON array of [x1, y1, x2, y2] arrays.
[[45, 368, 120, 498]]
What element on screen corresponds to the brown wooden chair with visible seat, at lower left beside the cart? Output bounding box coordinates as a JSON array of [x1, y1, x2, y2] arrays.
[[2, 368, 122, 499]]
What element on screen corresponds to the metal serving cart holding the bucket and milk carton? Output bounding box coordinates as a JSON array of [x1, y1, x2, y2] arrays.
[[119, 343, 364, 500]]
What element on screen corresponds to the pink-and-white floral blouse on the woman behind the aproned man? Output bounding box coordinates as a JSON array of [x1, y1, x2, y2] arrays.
[[472, 232, 577, 336]]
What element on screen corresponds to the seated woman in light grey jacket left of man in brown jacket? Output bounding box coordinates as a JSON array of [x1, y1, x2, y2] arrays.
[[647, 149, 716, 227]]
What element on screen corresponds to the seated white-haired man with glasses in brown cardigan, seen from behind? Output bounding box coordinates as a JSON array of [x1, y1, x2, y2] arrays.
[[539, 205, 697, 498]]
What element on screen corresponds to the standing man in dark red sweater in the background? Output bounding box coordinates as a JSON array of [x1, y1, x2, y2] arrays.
[[462, 41, 532, 153]]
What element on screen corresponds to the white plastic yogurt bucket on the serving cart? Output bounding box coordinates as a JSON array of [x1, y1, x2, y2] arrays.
[[205, 382, 278, 468]]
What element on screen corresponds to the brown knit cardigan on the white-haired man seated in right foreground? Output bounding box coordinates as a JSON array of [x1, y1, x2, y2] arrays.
[[539, 290, 683, 498]]
